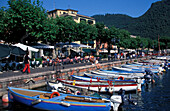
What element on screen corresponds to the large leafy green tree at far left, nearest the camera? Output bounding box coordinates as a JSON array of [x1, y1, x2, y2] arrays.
[[2, 0, 47, 43]]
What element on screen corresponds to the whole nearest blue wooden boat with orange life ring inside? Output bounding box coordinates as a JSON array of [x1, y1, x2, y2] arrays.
[[8, 87, 114, 111]]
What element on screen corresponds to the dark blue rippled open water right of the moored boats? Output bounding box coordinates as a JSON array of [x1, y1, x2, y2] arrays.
[[123, 71, 170, 111]]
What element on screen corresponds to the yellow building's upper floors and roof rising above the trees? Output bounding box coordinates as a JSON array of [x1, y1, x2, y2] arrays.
[[47, 9, 96, 24]]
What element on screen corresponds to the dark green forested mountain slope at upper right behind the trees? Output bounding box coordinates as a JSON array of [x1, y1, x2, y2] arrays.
[[92, 0, 170, 39]]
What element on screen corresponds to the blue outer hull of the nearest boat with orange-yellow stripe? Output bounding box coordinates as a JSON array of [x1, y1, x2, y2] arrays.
[[8, 88, 111, 111]]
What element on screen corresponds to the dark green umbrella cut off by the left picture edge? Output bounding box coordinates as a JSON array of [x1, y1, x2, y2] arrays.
[[0, 44, 11, 59]]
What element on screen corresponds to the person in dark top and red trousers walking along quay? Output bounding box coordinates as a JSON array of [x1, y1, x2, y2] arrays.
[[23, 52, 30, 73]]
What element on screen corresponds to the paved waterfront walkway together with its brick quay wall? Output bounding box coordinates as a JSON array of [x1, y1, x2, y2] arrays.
[[0, 58, 146, 96]]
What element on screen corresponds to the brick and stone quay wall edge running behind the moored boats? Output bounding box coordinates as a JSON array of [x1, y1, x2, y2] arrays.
[[0, 58, 146, 97]]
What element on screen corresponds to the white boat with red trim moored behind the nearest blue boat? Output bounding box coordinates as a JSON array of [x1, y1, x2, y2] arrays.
[[57, 79, 141, 93]]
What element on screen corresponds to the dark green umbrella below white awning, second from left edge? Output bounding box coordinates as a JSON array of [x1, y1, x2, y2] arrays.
[[10, 46, 26, 56]]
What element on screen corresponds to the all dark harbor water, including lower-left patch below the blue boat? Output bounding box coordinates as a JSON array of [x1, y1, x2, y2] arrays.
[[0, 71, 170, 111]]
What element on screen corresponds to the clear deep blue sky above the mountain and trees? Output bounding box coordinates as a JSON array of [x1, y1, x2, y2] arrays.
[[0, 0, 160, 17]]
